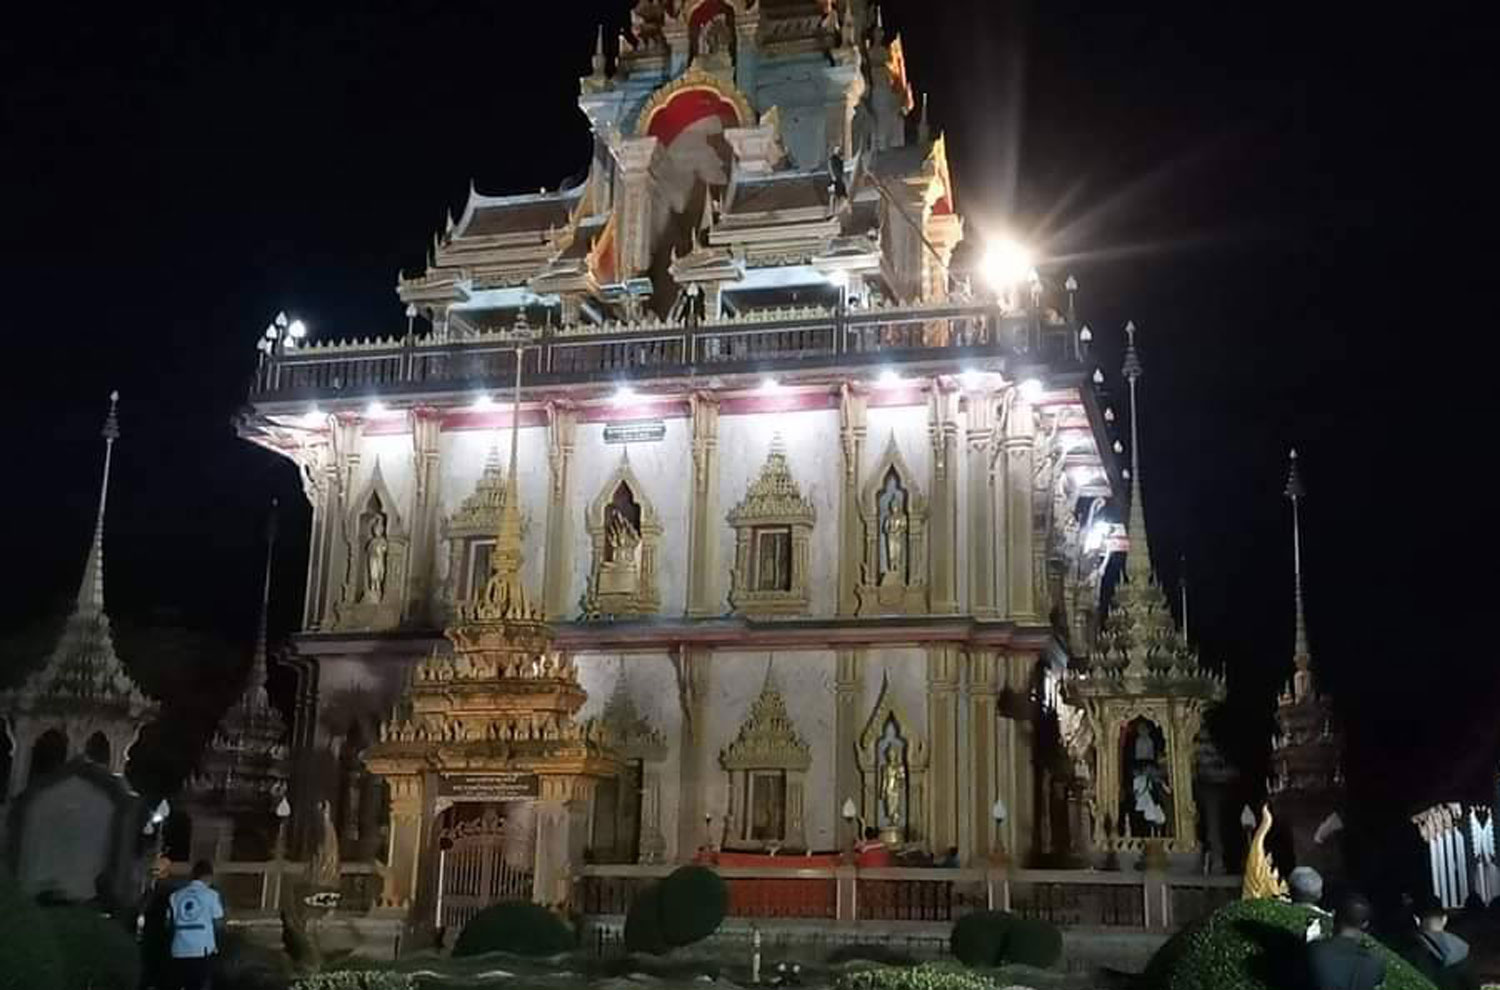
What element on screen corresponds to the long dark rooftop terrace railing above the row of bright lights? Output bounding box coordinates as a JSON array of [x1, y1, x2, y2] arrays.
[[251, 305, 1082, 404]]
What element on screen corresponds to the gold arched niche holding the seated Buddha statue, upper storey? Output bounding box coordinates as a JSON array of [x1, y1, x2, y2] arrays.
[[579, 456, 662, 618]]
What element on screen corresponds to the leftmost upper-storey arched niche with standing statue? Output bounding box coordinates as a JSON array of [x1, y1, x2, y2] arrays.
[[333, 461, 411, 629]]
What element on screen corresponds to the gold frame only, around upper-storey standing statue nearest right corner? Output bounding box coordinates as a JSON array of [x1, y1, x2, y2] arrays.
[[855, 432, 930, 615]]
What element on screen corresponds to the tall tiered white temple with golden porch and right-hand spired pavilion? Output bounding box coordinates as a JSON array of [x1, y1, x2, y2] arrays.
[[240, 0, 1223, 927]]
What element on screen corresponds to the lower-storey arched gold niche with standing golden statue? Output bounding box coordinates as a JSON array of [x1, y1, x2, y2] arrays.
[[858, 672, 927, 846]]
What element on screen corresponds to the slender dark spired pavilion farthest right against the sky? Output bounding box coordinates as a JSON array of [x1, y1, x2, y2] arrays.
[[1266, 450, 1344, 878]]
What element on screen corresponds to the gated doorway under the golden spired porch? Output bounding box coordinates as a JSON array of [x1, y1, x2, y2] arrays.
[[437, 801, 536, 933]]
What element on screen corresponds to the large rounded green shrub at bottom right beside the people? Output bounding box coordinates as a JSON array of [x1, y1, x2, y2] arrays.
[[1142, 900, 1434, 990]]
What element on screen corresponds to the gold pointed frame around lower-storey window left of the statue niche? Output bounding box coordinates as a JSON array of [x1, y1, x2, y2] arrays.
[[719, 668, 813, 852]]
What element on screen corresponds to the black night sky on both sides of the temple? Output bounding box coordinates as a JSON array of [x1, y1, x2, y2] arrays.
[[0, 0, 1500, 876]]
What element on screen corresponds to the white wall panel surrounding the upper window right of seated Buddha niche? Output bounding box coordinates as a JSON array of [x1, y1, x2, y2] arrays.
[[713, 410, 843, 615]]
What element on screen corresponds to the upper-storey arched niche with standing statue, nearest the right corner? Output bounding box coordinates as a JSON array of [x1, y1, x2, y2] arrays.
[[855, 432, 929, 615]]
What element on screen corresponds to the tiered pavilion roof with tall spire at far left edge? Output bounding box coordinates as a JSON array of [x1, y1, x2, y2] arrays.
[[0, 393, 156, 797]]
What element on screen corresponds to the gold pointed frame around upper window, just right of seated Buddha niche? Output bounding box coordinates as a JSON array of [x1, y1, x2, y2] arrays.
[[725, 435, 818, 617]]
